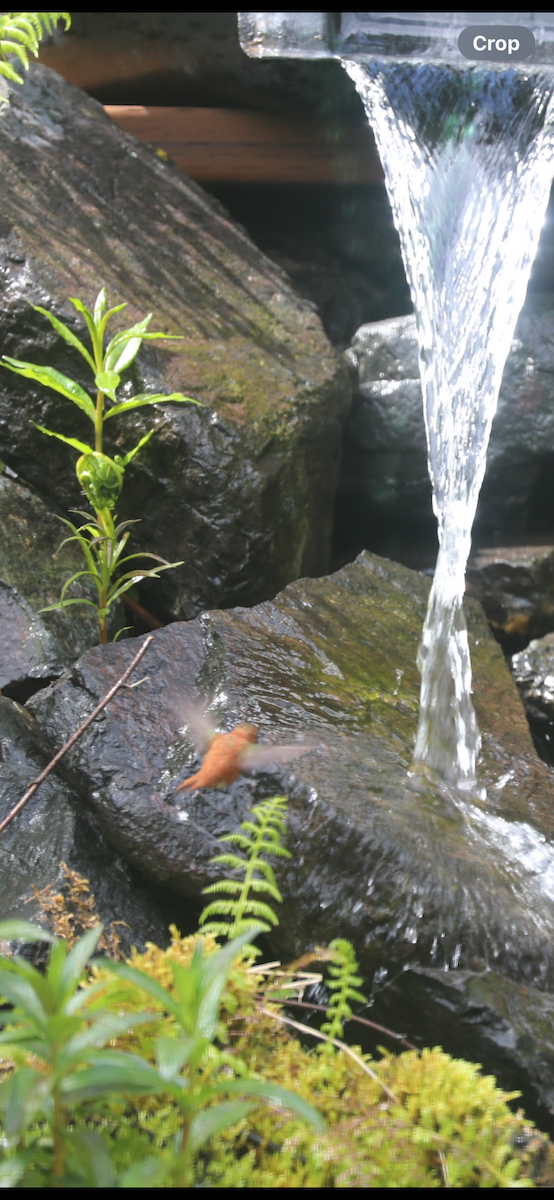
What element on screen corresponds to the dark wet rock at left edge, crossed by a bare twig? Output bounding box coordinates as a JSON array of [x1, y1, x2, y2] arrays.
[[0, 696, 182, 950]]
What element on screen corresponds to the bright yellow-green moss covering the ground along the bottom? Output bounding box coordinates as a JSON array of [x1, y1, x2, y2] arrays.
[[82, 930, 552, 1188]]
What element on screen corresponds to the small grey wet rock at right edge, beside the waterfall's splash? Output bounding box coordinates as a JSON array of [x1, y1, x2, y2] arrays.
[[512, 634, 554, 766]]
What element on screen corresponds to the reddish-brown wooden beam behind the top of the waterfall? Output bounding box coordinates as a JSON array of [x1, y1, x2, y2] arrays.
[[104, 104, 384, 184]]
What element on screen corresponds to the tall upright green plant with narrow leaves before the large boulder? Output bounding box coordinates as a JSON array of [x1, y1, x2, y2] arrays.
[[2, 288, 199, 644]]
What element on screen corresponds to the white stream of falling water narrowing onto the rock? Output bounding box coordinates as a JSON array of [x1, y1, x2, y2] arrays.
[[343, 60, 554, 791]]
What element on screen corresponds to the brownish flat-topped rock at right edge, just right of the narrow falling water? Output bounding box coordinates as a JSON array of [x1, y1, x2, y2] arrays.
[[465, 546, 554, 638]]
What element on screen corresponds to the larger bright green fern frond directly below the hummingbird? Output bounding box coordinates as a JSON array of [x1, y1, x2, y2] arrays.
[[199, 796, 290, 956]]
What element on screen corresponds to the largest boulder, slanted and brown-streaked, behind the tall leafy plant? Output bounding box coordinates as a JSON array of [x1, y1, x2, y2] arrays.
[[0, 66, 349, 616]]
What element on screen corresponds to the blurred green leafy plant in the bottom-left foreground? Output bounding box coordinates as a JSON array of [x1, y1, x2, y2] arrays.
[[0, 922, 325, 1187]]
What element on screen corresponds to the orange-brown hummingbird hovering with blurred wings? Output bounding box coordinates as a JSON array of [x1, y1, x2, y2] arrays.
[[175, 704, 319, 792]]
